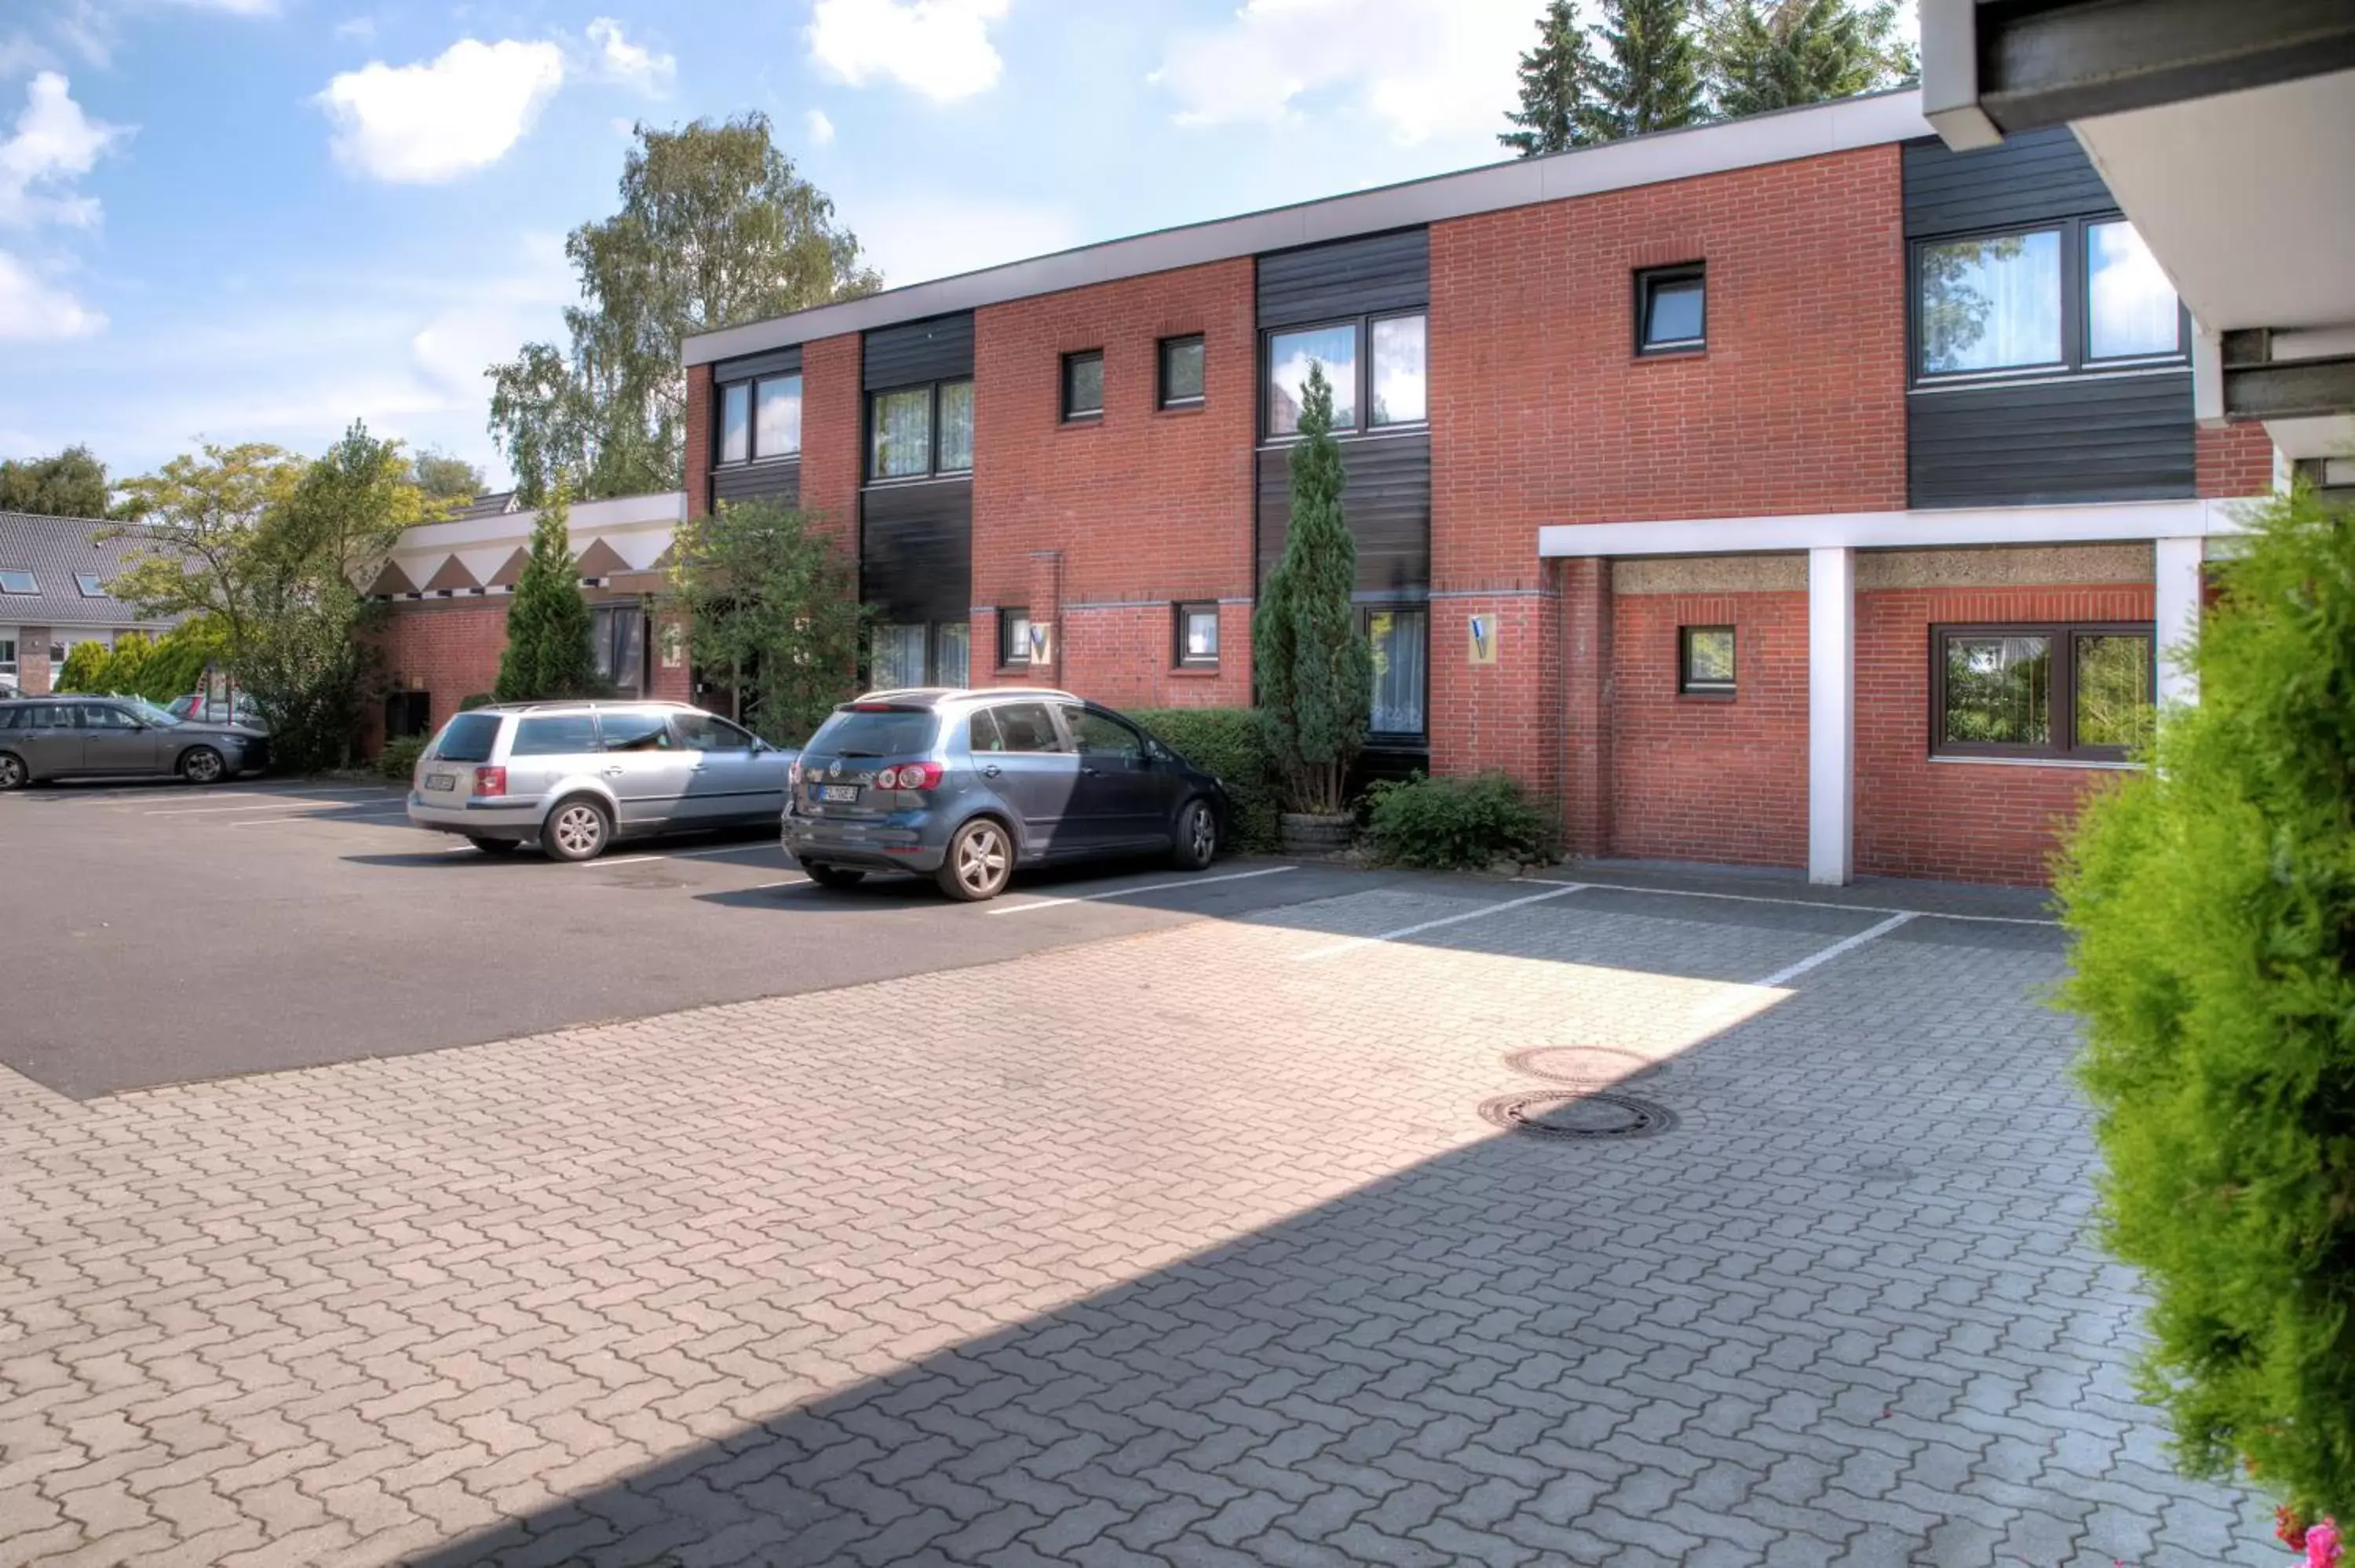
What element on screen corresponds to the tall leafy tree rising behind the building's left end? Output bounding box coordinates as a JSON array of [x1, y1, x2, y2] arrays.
[[487, 113, 881, 506]]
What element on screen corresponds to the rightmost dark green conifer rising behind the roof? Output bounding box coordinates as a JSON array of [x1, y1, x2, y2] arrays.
[[1705, 0, 1919, 118]]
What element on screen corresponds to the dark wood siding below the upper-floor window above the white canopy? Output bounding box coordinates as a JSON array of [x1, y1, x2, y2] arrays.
[[1905, 372, 2195, 506]]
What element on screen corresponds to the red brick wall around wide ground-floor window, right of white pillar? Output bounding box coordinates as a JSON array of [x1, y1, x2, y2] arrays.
[[1856, 584, 2155, 885]]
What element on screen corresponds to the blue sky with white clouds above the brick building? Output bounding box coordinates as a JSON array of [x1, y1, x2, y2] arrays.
[[0, 0, 1639, 490]]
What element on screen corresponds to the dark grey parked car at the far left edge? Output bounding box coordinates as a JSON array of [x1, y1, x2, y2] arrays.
[[0, 697, 271, 789]]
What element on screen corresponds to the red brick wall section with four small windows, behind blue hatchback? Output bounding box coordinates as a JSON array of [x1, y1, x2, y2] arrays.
[[973, 259, 1258, 706]]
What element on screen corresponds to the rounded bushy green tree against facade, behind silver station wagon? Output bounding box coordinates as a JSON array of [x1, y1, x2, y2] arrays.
[[666, 501, 867, 746]]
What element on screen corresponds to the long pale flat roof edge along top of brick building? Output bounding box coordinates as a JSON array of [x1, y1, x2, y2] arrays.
[[681, 87, 1936, 365]]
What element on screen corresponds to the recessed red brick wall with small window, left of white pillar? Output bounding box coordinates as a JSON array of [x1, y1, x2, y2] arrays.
[[1608, 593, 1806, 866]]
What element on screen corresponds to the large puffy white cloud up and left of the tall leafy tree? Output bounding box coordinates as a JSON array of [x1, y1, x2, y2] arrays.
[[318, 38, 565, 184]]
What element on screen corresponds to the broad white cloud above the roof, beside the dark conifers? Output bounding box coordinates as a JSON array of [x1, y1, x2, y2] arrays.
[[1149, 0, 1535, 144]]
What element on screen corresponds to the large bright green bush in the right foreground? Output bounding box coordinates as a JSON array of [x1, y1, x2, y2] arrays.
[[2058, 490, 2355, 1516]]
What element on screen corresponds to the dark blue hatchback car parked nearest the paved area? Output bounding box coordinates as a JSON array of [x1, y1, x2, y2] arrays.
[[782, 687, 1227, 899]]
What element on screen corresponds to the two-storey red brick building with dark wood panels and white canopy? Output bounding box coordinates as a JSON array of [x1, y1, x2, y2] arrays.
[[377, 94, 2273, 883]]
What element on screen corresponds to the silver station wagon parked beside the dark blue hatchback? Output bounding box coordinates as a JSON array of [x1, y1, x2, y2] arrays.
[[410, 702, 794, 859]]
